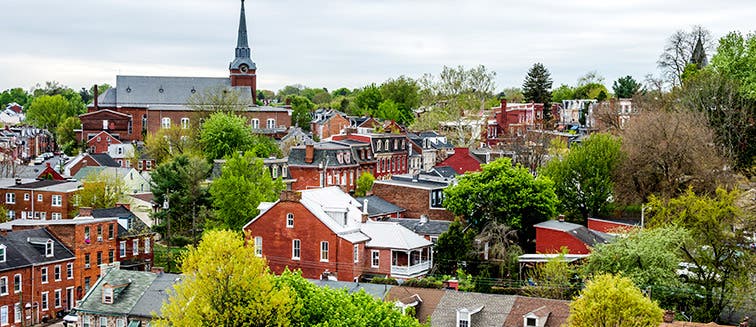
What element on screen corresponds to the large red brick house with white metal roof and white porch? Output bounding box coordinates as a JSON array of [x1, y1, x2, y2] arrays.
[[244, 187, 432, 281]]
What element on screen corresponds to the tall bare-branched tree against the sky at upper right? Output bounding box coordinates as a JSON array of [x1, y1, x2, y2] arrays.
[[657, 26, 712, 86]]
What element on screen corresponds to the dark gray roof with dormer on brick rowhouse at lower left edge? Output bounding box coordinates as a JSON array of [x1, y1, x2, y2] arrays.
[[0, 228, 74, 271]]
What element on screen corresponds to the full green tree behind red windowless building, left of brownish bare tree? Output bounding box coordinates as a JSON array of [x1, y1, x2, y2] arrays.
[[541, 133, 622, 224]]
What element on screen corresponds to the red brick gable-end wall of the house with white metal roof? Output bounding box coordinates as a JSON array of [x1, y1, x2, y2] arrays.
[[245, 201, 365, 281]]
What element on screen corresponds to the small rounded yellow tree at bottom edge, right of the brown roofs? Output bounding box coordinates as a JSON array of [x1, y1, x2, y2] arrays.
[[567, 274, 664, 327]]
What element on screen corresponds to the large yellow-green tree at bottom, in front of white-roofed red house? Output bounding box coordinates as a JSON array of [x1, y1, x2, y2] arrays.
[[155, 231, 299, 327]]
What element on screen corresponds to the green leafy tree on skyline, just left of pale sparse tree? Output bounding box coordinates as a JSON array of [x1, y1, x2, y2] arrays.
[[378, 76, 420, 125]]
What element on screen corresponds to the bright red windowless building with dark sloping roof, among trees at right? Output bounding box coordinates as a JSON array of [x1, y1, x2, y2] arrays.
[[533, 219, 609, 254]]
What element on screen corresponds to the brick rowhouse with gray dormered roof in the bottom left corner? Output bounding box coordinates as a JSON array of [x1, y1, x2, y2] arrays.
[[0, 229, 75, 327]]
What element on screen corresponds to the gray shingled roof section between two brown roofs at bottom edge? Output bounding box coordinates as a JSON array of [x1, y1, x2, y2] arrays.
[[431, 291, 516, 327]]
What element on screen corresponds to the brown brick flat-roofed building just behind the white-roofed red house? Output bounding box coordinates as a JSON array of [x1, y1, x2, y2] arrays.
[[373, 174, 454, 220]]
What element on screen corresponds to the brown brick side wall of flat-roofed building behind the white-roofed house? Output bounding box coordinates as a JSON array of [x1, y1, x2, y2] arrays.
[[373, 183, 454, 221]]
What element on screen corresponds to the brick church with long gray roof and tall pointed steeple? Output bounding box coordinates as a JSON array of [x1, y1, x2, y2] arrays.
[[77, 0, 292, 142]]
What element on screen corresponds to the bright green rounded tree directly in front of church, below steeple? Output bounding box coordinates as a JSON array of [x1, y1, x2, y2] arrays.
[[199, 112, 253, 160]]
